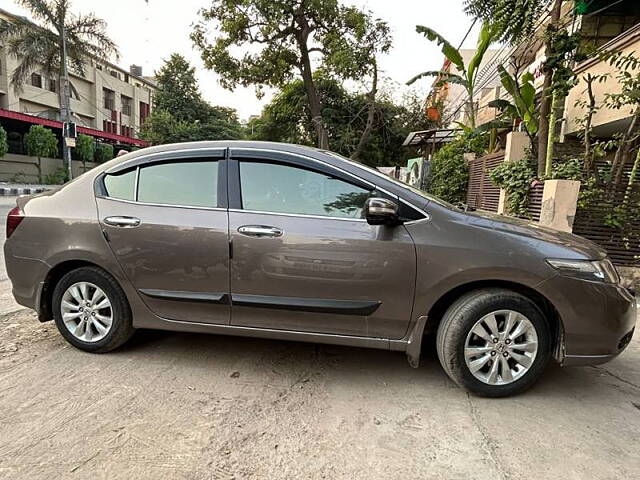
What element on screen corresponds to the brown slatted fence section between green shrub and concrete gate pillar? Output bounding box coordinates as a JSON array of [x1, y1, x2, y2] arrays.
[[467, 152, 504, 212]]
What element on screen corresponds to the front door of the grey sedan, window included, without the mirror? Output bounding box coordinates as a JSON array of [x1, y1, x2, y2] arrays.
[[229, 148, 416, 338]]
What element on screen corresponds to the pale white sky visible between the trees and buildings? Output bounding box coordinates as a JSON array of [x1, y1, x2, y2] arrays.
[[0, 0, 478, 120]]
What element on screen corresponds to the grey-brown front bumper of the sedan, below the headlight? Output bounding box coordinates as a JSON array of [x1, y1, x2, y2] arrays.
[[539, 275, 637, 365]]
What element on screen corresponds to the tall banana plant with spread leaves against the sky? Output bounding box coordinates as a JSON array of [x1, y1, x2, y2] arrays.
[[407, 23, 501, 128]]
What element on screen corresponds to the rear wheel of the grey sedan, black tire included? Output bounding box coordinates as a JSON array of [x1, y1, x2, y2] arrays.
[[52, 267, 134, 353]]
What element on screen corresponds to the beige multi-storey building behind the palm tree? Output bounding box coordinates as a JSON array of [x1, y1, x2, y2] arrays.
[[0, 9, 156, 153]]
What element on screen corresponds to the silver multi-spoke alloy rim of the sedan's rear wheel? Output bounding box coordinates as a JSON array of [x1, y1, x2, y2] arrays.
[[60, 282, 113, 343]]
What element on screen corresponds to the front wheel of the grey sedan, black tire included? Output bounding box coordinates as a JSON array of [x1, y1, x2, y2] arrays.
[[436, 288, 551, 397]]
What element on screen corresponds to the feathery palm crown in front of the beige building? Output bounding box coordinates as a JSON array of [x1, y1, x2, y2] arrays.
[[0, 0, 118, 92]]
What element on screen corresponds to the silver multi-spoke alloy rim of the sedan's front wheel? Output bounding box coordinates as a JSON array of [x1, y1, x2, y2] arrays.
[[464, 310, 538, 385]]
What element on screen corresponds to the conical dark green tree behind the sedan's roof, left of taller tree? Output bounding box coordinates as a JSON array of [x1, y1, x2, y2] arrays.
[[140, 53, 244, 145]]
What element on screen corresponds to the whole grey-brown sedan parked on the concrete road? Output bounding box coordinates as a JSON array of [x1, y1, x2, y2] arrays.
[[5, 142, 636, 397]]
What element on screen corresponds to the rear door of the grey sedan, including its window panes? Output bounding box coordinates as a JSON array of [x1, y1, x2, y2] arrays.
[[97, 149, 230, 324]]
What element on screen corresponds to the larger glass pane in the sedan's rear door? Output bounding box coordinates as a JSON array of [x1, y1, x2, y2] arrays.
[[138, 160, 218, 207]]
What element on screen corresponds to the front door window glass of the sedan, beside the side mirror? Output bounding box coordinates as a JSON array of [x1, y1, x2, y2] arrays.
[[240, 161, 370, 218]]
